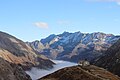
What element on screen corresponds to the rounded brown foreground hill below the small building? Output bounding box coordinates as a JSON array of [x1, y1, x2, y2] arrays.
[[38, 65, 120, 80]]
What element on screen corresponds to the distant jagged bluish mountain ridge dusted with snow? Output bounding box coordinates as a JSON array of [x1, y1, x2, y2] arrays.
[[27, 32, 120, 62]]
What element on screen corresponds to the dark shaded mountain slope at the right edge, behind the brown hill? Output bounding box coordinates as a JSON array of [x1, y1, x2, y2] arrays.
[[95, 40, 120, 76]]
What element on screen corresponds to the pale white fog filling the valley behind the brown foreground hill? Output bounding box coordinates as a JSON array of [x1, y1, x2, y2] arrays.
[[26, 60, 77, 80]]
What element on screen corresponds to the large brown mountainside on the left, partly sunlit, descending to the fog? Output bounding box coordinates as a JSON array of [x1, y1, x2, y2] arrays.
[[0, 32, 54, 70]]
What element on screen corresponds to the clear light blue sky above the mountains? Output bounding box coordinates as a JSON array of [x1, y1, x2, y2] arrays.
[[0, 0, 120, 41]]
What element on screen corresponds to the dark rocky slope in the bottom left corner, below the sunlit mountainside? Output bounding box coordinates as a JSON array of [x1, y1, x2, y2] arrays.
[[0, 58, 31, 80]]
